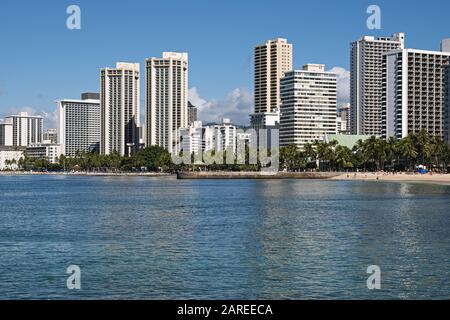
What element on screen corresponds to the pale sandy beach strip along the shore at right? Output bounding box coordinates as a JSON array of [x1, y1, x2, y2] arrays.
[[331, 172, 450, 185]]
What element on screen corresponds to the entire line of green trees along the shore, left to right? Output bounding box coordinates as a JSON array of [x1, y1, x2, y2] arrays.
[[7, 131, 450, 172]]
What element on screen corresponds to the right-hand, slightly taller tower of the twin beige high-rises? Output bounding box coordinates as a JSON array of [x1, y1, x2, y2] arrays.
[[145, 52, 188, 153]]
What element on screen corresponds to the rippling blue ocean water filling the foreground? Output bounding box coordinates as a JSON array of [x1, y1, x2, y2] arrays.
[[0, 176, 450, 299]]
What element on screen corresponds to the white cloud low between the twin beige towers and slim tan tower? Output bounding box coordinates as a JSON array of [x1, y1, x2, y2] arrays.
[[189, 87, 253, 125]]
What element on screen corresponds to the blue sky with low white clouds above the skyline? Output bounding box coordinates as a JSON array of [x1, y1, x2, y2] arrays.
[[0, 0, 450, 128]]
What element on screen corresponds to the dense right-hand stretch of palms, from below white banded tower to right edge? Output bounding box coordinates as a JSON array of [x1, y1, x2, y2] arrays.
[[280, 131, 450, 172]]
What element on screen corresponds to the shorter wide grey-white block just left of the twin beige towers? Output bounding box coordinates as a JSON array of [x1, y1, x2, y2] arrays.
[[57, 93, 101, 157]]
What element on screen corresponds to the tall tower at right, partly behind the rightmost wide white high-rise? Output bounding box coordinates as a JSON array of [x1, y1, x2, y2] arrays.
[[350, 33, 405, 135]]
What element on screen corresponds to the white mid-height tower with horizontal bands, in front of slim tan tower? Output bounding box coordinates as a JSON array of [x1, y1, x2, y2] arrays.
[[280, 64, 337, 149]]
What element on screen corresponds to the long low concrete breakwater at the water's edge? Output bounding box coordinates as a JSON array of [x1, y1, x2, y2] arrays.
[[177, 171, 342, 180]]
